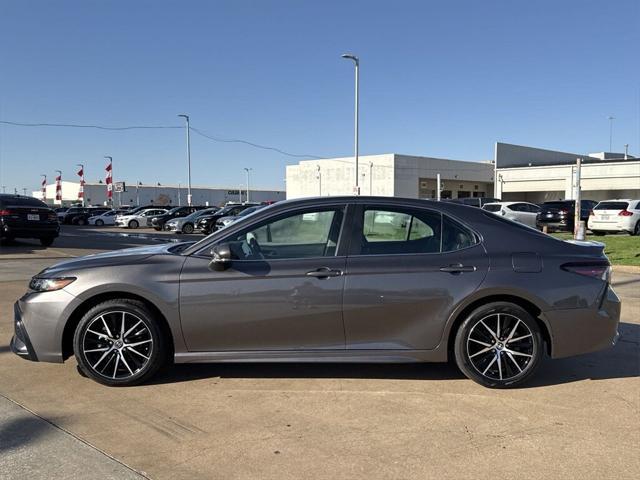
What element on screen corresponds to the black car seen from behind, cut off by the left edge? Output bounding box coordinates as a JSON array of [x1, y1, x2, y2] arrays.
[[0, 194, 60, 247]]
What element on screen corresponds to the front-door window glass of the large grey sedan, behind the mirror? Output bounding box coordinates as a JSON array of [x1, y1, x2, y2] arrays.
[[225, 209, 343, 260]]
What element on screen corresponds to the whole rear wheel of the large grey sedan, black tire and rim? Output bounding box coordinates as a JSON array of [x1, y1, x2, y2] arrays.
[[454, 302, 544, 388]]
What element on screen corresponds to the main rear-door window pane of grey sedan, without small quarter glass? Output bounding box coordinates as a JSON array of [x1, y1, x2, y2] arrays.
[[360, 207, 441, 255]]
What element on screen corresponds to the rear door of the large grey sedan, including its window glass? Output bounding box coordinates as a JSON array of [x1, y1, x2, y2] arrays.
[[343, 204, 489, 350]]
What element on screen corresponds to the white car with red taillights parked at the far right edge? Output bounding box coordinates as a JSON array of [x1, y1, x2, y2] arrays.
[[587, 199, 640, 235]]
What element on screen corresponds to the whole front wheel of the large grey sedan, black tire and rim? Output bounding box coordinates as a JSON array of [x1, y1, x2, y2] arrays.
[[73, 299, 167, 387]]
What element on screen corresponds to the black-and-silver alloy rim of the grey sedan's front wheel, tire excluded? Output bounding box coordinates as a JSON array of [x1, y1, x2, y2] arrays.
[[81, 311, 154, 380]]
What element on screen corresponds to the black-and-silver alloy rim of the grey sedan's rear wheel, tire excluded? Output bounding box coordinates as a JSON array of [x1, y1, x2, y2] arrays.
[[466, 313, 537, 381]]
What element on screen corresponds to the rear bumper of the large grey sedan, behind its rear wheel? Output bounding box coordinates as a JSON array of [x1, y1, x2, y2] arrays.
[[543, 286, 620, 358]]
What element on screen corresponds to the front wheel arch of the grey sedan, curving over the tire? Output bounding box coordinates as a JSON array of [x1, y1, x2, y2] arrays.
[[62, 291, 175, 361]]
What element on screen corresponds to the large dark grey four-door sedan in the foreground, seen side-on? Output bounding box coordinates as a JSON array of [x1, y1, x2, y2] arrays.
[[11, 196, 620, 388]]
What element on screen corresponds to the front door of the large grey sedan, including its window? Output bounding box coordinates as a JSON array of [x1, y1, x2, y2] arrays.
[[180, 205, 346, 351]]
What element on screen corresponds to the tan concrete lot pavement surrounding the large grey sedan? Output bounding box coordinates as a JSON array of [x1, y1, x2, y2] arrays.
[[0, 227, 640, 480]]
